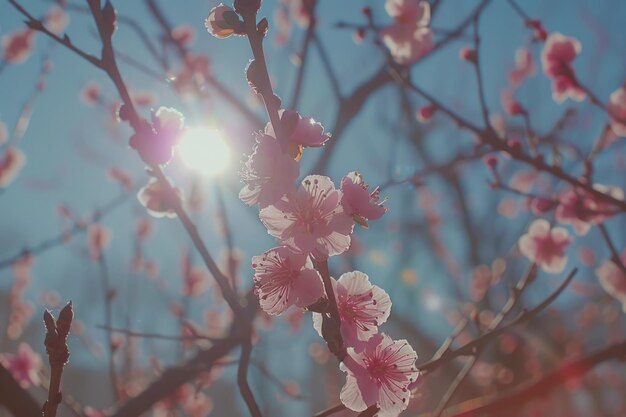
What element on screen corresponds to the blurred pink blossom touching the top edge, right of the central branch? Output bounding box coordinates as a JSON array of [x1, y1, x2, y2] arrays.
[[380, 0, 433, 65]]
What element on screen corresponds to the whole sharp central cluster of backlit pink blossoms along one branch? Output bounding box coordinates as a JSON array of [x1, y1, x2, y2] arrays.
[[239, 105, 418, 416]]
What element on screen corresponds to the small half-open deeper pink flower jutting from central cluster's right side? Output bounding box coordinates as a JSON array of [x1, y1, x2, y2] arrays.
[[341, 171, 387, 228]]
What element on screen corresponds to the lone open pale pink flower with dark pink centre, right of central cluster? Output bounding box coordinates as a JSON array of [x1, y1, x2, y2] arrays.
[[519, 219, 572, 274]]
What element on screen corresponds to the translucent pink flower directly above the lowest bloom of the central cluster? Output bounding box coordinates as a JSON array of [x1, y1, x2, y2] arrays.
[[313, 271, 391, 352]]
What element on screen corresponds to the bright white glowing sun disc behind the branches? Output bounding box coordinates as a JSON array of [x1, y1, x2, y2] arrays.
[[176, 127, 230, 177]]
